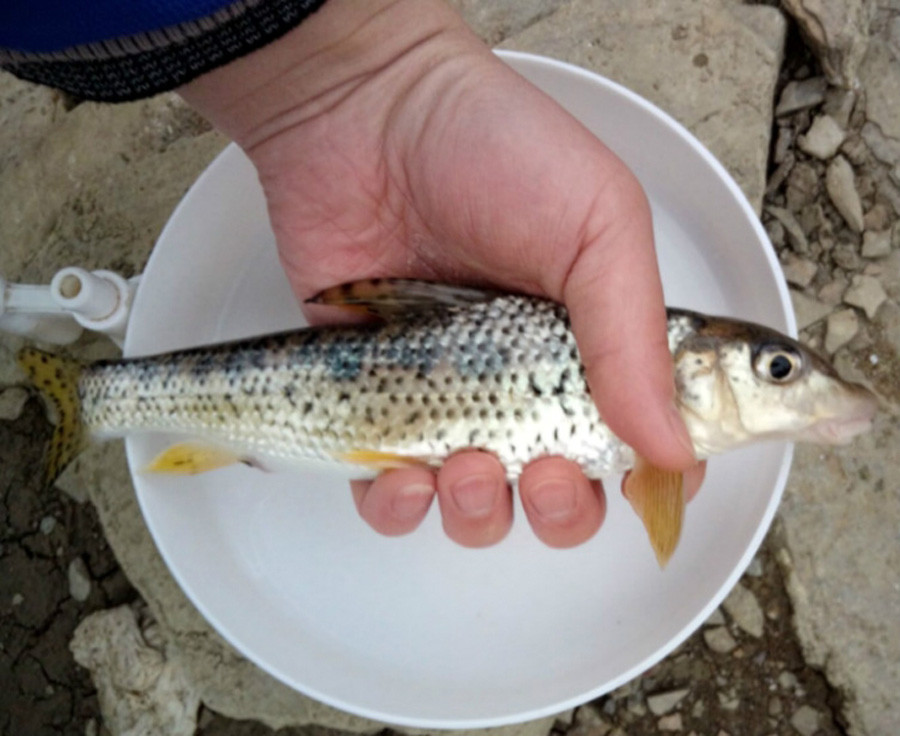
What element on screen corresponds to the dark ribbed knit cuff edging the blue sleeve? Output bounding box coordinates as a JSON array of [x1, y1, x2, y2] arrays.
[[0, 0, 325, 102]]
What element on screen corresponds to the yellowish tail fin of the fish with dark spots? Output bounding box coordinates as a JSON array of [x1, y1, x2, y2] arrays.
[[18, 347, 87, 485]]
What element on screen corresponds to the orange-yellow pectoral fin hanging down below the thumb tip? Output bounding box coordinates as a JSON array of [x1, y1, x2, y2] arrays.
[[624, 457, 685, 568]]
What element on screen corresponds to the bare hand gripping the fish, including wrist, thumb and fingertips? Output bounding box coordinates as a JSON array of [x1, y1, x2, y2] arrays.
[[182, 0, 703, 547]]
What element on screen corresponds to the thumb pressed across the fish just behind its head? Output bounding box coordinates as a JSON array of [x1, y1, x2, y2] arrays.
[[563, 164, 696, 470]]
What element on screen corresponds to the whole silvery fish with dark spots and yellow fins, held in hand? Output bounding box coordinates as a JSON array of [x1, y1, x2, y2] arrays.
[[19, 279, 877, 566]]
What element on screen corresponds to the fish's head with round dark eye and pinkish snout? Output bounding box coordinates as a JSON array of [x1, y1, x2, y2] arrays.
[[673, 313, 878, 457]]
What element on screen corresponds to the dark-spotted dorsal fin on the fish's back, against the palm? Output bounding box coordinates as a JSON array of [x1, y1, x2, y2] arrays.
[[306, 279, 499, 319]]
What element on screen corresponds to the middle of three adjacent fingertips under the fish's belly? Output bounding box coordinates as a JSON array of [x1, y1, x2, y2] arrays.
[[437, 450, 512, 547]]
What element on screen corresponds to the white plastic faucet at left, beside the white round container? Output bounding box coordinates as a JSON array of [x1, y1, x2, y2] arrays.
[[0, 267, 139, 347]]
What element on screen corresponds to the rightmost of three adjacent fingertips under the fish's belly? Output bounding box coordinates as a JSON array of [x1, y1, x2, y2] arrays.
[[519, 457, 606, 547]]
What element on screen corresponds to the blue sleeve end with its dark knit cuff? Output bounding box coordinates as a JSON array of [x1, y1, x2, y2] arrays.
[[0, 0, 325, 102]]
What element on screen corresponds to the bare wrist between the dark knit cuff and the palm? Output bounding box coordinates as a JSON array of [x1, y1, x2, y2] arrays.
[[178, 0, 485, 152]]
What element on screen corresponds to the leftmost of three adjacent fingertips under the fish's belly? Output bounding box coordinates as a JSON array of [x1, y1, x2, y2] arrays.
[[350, 468, 435, 537]]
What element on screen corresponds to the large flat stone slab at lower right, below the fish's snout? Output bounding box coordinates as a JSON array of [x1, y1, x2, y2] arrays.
[[779, 415, 900, 736]]
